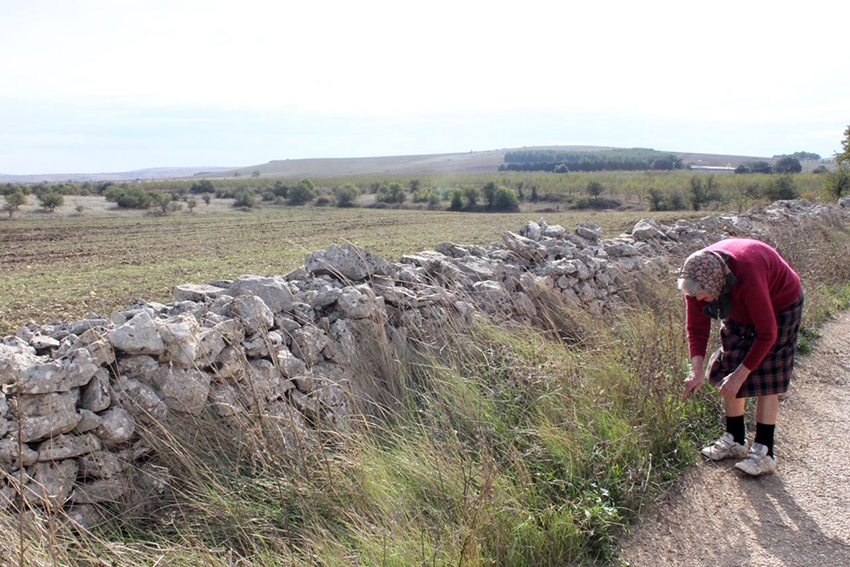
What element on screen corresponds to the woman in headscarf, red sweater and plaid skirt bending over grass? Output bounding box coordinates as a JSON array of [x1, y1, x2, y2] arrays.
[[678, 239, 803, 476]]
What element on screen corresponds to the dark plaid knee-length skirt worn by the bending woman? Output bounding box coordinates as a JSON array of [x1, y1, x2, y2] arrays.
[[708, 295, 803, 398]]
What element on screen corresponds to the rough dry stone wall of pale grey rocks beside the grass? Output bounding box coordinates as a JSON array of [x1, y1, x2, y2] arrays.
[[0, 199, 850, 523]]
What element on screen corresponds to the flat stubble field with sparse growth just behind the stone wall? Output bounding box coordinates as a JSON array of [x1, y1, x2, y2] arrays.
[[0, 197, 704, 335]]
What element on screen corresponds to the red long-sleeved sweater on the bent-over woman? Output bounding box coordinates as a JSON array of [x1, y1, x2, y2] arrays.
[[687, 238, 803, 371]]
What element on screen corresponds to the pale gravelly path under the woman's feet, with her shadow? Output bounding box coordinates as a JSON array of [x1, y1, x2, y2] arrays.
[[620, 313, 850, 567]]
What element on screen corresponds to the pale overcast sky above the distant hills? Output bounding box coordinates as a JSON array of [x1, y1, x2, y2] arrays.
[[0, 0, 850, 174]]
